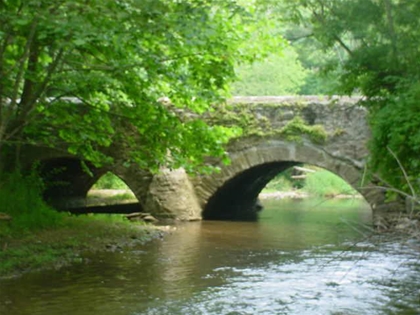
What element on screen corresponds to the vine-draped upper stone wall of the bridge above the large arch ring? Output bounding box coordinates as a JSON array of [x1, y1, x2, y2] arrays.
[[213, 96, 370, 166]]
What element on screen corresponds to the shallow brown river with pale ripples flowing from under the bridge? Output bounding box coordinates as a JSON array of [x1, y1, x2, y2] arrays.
[[0, 200, 420, 315]]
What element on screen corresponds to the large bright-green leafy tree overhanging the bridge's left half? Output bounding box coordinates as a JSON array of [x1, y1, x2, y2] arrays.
[[0, 0, 278, 173]]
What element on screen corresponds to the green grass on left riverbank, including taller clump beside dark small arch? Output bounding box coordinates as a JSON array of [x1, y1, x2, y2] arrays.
[[0, 172, 160, 277]]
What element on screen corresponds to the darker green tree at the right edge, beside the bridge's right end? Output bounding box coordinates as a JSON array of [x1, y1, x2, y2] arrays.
[[270, 0, 420, 193]]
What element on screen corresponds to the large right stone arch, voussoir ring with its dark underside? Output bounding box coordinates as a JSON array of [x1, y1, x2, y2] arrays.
[[195, 139, 383, 219]]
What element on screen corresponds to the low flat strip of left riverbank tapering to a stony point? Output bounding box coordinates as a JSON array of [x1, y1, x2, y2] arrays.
[[0, 215, 170, 279]]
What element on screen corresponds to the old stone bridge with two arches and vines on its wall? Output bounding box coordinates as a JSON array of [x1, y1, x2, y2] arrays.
[[11, 96, 383, 220]]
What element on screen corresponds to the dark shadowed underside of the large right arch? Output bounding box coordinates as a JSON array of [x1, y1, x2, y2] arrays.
[[203, 161, 300, 221]]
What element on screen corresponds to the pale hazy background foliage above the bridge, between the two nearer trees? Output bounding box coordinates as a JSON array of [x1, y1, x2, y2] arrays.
[[256, 0, 345, 95]]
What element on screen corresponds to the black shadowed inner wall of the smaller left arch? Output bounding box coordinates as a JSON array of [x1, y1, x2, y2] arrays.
[[39, 157, 106, 208]]
